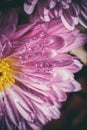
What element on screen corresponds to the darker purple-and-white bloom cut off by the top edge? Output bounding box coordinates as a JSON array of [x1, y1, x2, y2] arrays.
[[24, 0, 87, 30]]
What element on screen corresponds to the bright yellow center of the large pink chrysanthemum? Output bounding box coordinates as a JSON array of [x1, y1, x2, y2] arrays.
[[0, 58, 15, 91]]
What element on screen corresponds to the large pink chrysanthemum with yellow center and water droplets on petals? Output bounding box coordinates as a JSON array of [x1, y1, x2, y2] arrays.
[[0, 9, 87, 130]]
